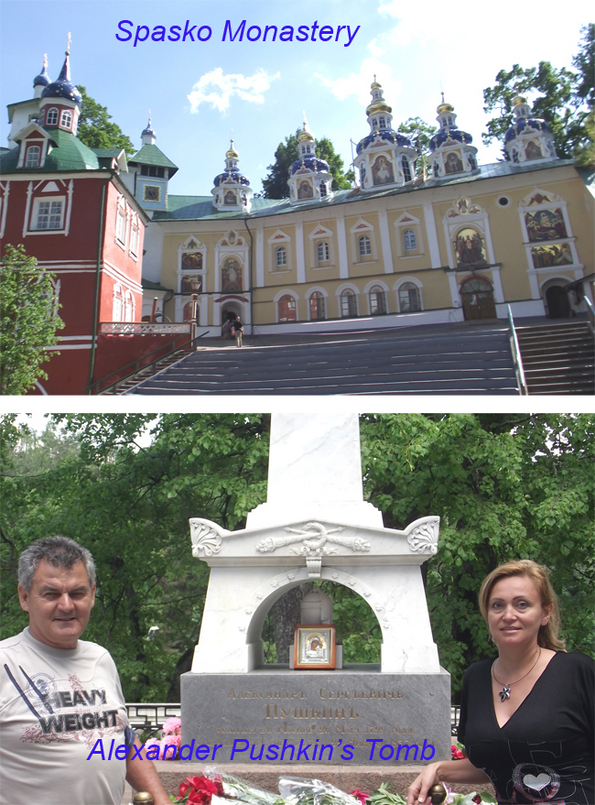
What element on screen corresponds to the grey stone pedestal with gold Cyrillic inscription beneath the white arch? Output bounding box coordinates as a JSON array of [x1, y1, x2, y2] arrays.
[[181, 665, 451, 773]]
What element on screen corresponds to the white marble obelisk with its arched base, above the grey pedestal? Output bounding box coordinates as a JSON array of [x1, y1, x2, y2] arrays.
[[190, 413, 440, 673]]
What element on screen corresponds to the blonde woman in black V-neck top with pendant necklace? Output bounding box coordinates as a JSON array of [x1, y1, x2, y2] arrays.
[[407, 560, 595, 805]]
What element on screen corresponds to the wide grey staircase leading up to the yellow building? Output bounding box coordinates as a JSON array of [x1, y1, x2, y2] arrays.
[[125, 323, 519, 395]]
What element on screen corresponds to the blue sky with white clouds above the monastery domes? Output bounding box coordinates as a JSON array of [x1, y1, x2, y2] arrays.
[[0, 0, 588, 195]]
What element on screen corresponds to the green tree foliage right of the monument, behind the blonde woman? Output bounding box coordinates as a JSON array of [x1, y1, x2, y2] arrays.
[[361, 414, 595, 694]]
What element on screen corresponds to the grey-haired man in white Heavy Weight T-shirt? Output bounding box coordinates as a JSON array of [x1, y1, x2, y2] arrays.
[[0, 537, 170, 805]]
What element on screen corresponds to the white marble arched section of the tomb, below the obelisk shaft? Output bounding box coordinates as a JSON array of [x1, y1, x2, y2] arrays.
[[190, 516, 440, 673]]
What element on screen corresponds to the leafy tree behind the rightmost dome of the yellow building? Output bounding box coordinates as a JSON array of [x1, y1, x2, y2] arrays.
[[482, 23, 595, 165]]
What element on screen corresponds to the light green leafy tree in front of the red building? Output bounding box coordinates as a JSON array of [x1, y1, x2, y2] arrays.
[[0, 244, 64, 394]]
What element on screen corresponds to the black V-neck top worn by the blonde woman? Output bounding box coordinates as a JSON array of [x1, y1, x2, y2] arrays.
[[459, 652, 595, 805]]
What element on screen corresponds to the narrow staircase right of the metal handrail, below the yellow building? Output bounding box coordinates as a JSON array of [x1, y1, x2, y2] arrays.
[[517, 320, 595, 395]]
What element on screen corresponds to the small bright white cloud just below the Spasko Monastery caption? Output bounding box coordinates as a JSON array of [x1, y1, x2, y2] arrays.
[[187, 67, 281, 112]]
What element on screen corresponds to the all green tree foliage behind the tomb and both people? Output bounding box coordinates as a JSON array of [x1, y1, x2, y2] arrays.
[[0, 414, 595, 701]]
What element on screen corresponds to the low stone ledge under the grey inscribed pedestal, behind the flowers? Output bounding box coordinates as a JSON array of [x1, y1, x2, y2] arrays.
[[128, 760, 493, 805]]
